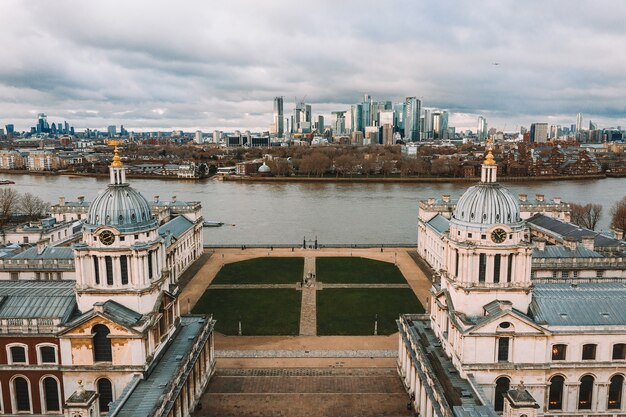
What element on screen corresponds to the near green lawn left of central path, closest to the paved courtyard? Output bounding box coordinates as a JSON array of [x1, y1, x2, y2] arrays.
[[192, 288, 301, 336]]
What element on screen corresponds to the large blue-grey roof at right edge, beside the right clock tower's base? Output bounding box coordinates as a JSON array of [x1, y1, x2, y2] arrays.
[[529, 283, 626, 326]]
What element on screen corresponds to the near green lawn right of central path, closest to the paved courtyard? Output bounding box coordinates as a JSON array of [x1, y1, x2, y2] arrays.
[[317, 290, 424, 336]]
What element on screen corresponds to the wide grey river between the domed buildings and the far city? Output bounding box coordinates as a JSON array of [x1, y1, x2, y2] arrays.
[[5, 175, 626, 244]]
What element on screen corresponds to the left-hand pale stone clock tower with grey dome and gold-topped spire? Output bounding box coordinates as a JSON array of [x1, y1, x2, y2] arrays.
[[74, 141, 169, 314]]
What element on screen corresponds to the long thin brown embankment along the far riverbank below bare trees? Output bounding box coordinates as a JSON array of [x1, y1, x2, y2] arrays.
[[223, 174, 607, 183]]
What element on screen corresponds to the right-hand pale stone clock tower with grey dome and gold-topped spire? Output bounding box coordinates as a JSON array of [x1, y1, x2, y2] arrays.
[[442, 143, 532, 316]]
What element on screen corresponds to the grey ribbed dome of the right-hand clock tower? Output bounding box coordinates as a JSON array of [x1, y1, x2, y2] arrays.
[[453, 183, 521, 225]]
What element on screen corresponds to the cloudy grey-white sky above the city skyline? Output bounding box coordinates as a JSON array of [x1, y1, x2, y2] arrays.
[[0, 0, 626, 132]]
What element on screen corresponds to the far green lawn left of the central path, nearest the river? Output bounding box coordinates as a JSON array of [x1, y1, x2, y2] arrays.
[[213, 257, 304, 284]]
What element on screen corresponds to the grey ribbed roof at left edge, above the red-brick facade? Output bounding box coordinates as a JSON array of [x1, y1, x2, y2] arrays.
[[0, 281, 76, 322]]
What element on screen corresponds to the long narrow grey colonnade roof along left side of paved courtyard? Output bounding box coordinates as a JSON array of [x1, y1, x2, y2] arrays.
[[108, 316, 207, 417]]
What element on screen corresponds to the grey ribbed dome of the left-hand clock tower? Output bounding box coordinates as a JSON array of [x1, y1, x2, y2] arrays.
[[85, 184, 157, 233]]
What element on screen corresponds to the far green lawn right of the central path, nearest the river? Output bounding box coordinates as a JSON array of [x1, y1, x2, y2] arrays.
[[315, 257, 406, 284]]
